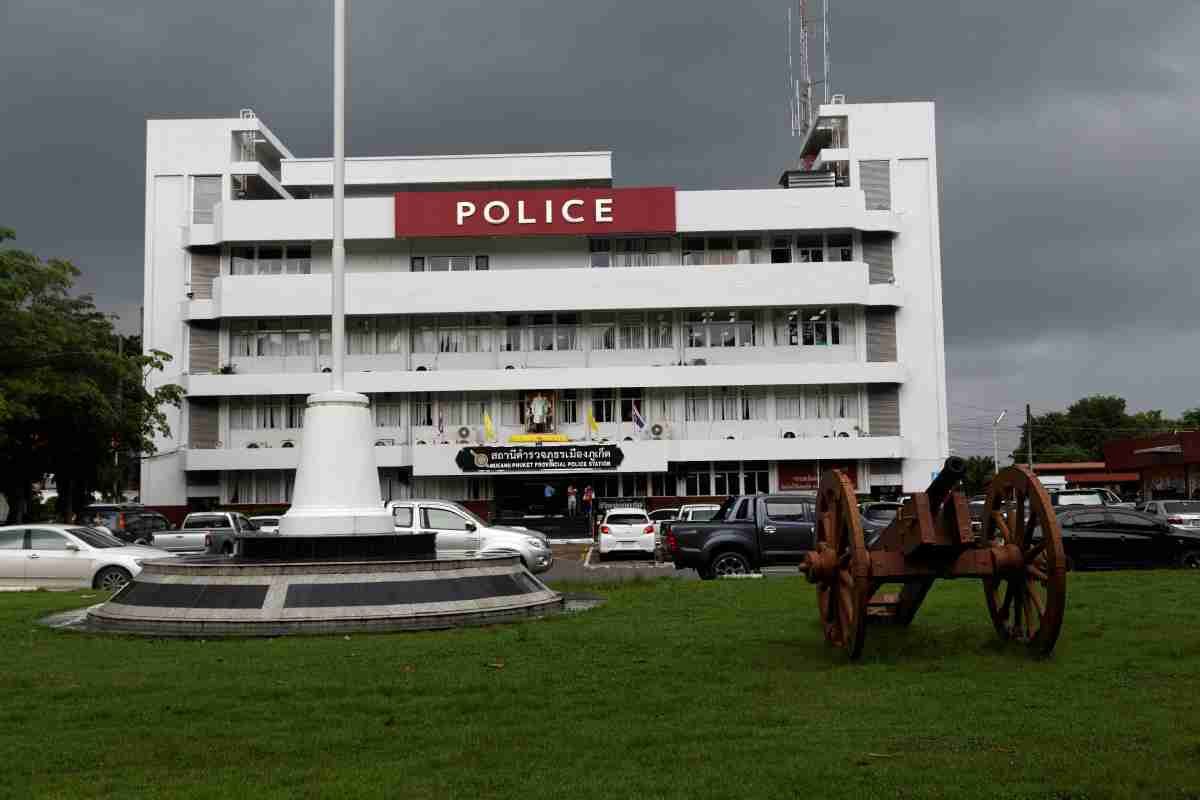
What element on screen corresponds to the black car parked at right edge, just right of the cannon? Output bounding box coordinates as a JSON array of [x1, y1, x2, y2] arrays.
[[1051, 506, 1200, 570]]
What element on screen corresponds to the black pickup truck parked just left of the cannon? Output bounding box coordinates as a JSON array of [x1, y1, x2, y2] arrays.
[[662, 494, 816, 579]]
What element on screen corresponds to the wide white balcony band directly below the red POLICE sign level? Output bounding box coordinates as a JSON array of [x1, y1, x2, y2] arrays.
[[184, 261, 904, 320]]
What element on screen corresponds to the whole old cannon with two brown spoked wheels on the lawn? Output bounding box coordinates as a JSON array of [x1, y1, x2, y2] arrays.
[[800, 456, 1067, 658]]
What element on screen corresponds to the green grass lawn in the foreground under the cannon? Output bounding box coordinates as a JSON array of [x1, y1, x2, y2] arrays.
[[0, 571, 1200, 800]]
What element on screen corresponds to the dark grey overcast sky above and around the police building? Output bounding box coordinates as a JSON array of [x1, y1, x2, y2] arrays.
[[0, 0, 1200, 452]]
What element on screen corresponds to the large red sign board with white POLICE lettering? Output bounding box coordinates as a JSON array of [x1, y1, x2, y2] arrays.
[[396, 186, 676, 237]]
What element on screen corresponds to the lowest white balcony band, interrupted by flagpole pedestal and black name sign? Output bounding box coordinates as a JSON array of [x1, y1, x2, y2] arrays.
[[184, 437, 906, 476]]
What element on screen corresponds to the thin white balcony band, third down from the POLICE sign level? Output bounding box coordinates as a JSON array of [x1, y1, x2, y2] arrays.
[[181, 362, 907, 397]]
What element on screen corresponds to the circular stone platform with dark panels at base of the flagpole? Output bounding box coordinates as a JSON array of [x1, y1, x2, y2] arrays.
[[88, 557, 563, 637]]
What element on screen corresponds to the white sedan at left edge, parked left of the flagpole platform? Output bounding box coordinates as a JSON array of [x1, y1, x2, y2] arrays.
[[0, 524, 170, 591]]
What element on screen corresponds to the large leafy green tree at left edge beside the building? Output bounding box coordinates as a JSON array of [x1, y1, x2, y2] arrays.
[[0, 228, 182, 521]]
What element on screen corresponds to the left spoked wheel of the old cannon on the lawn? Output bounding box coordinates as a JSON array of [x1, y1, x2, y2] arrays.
[[808, 470, 871, 658]]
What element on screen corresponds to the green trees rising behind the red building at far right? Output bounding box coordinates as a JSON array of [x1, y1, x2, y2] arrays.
[[1012, 395, 1180, 464]]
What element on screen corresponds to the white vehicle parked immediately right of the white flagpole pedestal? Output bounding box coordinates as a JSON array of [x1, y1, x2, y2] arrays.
[[388, 499, 554, 573]]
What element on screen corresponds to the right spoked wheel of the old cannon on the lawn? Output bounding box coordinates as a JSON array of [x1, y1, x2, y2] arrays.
[[983, 467, 1067, 655]]
